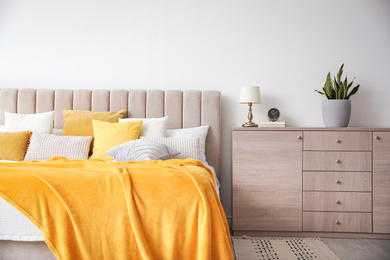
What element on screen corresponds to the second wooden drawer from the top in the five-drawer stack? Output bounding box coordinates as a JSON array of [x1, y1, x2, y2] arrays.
[[303, 151, 372, 172]]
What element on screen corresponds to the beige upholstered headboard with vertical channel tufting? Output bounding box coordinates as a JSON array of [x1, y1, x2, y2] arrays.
[[0, 88, 221, 177]]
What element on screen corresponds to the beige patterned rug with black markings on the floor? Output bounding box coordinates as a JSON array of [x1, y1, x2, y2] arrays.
[[232, 236, 340, 260]]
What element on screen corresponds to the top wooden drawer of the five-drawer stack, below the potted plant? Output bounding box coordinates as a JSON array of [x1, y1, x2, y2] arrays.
[[303, 131, 372, 151]]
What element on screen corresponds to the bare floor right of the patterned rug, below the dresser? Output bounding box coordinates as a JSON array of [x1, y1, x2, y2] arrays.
[[321, 238, 390, 260]]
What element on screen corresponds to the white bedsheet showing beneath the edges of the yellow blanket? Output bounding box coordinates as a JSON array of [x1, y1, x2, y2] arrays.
[[0, 160, 219, 241]]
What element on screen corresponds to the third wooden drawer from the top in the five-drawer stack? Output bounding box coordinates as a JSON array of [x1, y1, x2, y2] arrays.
[[303, 172, 371, 191]]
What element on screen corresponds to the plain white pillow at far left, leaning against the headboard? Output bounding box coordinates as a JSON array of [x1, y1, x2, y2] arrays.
[[4, 111, 54, 134]]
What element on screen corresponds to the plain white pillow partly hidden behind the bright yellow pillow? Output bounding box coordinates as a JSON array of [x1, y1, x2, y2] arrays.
[[119, 116, 168, 136]]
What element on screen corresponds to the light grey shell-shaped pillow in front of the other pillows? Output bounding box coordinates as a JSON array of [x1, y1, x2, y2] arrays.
[[107, 139, 180, 162]]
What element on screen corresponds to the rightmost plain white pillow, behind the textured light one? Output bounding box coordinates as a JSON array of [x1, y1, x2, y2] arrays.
[[166, 125, 209, 162]]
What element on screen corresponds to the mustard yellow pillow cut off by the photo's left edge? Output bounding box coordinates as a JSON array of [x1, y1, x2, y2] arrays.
[[0, 131, 31, 161]]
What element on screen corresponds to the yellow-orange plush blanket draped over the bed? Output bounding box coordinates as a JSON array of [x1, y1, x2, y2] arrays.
[[0, 158, 233, 260]]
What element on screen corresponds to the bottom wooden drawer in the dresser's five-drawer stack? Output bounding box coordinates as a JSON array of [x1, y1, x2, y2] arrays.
[[303, 212, 372, 233]]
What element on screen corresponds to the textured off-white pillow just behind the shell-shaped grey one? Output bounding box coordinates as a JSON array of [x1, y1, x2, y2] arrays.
[[141, 136, 201, 160]]
